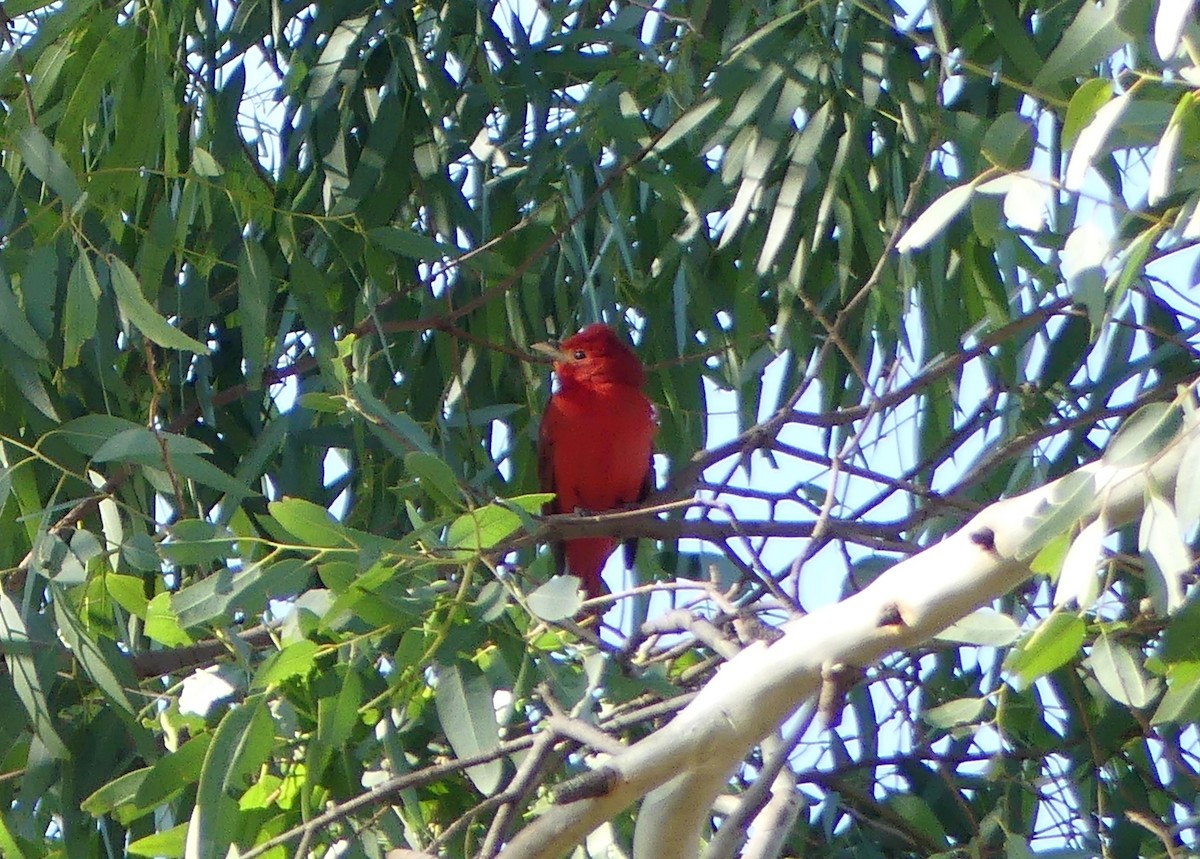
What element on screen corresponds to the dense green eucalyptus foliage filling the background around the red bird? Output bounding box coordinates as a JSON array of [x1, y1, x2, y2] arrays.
[[0, 0, 1200, 858]]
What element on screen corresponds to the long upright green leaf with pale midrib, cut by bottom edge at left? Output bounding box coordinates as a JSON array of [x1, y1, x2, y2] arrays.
[[187, 695, 275, 859]]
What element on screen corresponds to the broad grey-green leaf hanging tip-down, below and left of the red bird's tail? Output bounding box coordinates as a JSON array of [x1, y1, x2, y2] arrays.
[[433, 662, 504, 795]]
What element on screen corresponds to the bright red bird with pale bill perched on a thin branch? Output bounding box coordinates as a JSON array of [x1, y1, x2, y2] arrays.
[[533, 324, 656, 599]]
